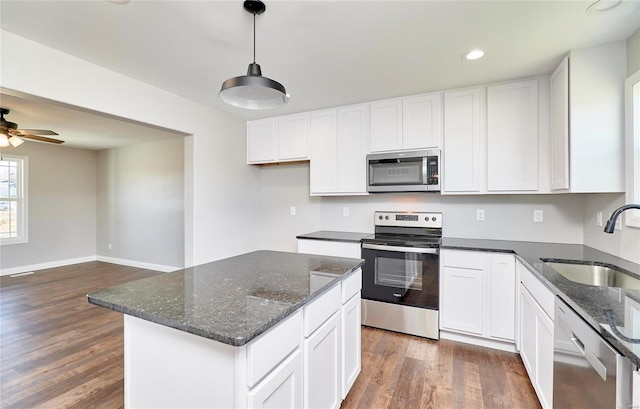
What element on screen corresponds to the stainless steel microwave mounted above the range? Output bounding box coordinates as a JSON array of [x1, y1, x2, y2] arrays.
[[367, 149, 440, 193]]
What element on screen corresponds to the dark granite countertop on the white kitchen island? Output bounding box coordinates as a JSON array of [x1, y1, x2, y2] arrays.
[[87, 251, 364, 346]]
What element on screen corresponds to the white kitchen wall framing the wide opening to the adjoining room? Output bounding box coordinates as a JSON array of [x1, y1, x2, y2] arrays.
[[0, 30, 260, 266]]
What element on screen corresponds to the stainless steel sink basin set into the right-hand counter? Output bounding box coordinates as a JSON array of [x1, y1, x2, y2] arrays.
[[543, 260, 640, 290]]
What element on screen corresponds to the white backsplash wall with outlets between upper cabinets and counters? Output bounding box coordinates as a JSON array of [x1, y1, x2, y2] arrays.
[[260, 164, 584, 251]]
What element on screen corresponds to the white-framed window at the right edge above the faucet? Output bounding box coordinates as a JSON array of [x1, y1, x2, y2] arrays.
[[625, 71, 640, 227]]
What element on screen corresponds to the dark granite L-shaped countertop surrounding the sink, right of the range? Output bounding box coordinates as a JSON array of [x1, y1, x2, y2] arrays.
[[440, 237, 640, 367]]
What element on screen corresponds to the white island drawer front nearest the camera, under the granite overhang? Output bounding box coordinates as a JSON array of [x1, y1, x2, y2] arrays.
[[247, 311, 302, 388]]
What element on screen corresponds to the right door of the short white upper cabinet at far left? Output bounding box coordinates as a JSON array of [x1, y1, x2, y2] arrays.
[[278, 112, 309, 160]]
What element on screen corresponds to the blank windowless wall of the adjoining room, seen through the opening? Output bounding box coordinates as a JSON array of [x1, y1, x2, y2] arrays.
[[96, 138, 184, 270]]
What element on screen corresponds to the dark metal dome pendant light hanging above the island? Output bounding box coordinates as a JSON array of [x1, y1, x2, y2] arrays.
[[218, 0, 289, 109]]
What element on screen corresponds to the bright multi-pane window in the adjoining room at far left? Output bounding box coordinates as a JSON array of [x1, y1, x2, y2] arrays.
[[0, 155, 28, 245]]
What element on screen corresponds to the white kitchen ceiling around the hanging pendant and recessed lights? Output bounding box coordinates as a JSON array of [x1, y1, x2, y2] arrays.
[[0, 0, 640, 149]]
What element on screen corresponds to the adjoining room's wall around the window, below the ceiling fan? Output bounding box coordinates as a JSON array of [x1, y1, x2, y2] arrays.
[[0, 141, 97, 273]]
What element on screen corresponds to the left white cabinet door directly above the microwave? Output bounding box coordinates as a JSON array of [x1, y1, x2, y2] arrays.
[[369, 98, 402, 152]]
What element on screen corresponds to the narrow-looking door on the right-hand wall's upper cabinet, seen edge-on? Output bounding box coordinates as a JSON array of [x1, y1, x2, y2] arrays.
[[551, 57, 569, 190]]
